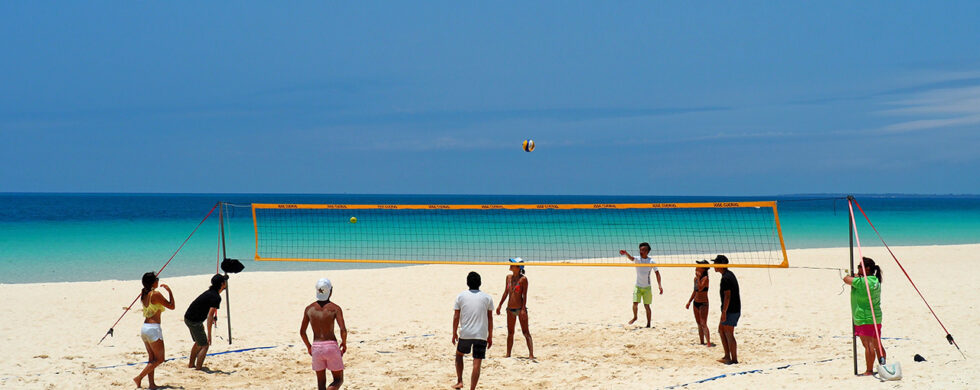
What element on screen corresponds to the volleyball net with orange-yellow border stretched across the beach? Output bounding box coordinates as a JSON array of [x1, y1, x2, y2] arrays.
[[252, 201, 789, 268]]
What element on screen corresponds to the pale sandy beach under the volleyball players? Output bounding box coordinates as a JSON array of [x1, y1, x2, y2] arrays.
[[0, 245, 980, 389]]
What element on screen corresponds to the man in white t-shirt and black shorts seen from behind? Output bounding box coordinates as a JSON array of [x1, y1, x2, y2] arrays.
[[453, 272, 493, 390]]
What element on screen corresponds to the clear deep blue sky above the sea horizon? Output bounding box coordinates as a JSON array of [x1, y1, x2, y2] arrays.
[[0, 1, 980, 195]]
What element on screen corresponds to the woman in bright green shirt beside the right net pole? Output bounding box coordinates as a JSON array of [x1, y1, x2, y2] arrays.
[[844, 257, 885, 375]]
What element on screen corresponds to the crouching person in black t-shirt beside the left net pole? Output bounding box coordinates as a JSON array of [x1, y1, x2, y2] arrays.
[[184, 274, 228, 370]]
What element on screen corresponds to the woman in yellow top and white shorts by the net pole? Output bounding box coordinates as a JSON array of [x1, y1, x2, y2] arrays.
[[133, 272, 174, 389]]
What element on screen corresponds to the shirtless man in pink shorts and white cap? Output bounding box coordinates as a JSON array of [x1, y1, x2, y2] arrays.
[[299, 278, 347, 390]]
